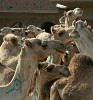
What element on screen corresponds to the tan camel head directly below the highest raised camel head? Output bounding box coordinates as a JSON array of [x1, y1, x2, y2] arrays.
[[51, 26, 79, 44]]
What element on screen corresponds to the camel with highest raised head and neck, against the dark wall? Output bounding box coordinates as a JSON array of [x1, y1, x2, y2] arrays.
[[51, 8, 83, 33]]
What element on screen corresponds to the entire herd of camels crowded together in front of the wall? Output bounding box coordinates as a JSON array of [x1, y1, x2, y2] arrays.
[[0, 8, 93, 100]]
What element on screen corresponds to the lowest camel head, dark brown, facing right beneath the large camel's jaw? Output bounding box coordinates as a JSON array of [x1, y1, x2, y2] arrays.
[[38, 62, 70, 76]]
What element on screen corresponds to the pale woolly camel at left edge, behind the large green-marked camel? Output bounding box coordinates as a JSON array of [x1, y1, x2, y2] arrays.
[[0, 34, 22, 70]]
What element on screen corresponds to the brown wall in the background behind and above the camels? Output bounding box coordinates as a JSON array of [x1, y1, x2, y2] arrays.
[[0, 0, 93, 28]]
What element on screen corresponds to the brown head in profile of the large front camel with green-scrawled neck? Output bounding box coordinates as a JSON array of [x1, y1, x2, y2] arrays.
[[25, 38, 66, 61]]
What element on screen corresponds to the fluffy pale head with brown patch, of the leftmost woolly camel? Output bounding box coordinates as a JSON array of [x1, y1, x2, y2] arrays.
[[0, 34, 22, 54]]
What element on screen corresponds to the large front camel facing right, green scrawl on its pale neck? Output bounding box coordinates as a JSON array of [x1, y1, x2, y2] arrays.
[[0, 38, 66, 100]]
